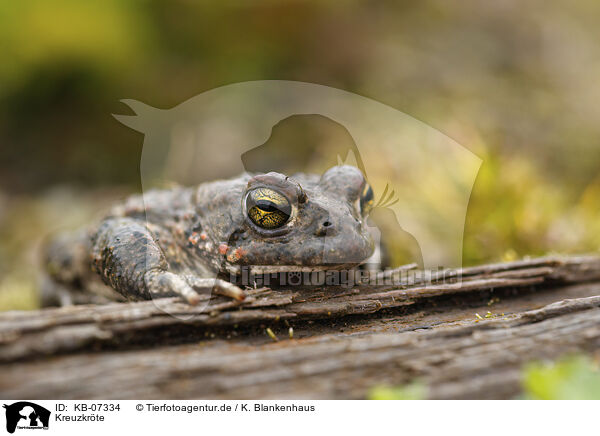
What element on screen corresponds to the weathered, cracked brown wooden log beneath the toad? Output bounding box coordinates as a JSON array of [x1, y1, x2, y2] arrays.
[[0, 257, 600, 398]]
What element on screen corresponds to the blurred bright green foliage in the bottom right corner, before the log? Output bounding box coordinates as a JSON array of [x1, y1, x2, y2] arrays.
[[523, 355, 600, 400]]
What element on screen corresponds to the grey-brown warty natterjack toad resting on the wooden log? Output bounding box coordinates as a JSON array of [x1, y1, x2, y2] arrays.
[[45, 166, 373, 304]]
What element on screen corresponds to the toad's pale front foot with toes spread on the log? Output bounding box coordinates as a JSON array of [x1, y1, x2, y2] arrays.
[[145, 271, 246, 306]]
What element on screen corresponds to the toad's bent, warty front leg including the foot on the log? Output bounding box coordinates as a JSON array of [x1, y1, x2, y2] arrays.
[[92, 218, 244, 305]]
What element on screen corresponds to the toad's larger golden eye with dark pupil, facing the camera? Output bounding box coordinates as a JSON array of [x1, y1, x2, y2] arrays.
[[246, 188, 292, 229]]
